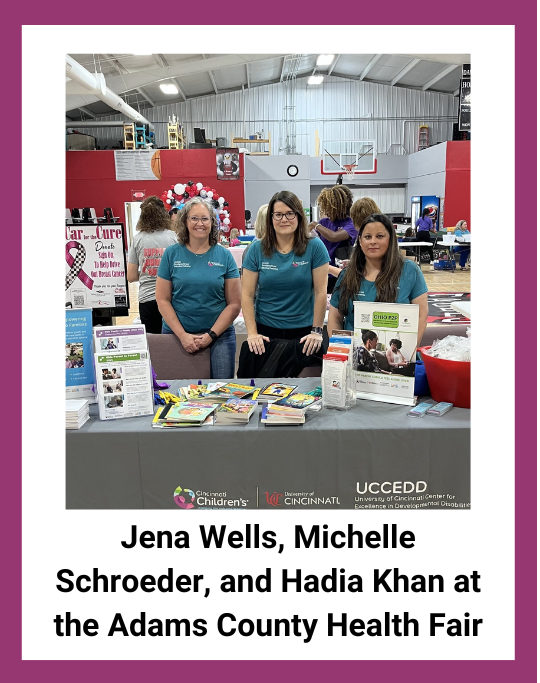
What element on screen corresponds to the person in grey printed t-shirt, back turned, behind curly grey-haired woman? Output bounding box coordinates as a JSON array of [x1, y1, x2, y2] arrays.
[[127, 197, 176, 334]]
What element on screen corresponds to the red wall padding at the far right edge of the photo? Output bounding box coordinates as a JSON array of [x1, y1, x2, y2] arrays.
[[444, 140, 472, 229]]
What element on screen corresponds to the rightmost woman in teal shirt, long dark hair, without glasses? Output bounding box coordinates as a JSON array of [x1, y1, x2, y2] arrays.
[[328, 213, 428, 342]]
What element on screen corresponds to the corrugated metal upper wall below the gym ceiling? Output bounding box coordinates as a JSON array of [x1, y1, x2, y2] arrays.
[[80, 76, 457, 156]]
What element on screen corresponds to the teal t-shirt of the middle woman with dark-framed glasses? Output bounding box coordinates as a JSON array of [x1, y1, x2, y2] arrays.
[[243, 237, 329, 329]]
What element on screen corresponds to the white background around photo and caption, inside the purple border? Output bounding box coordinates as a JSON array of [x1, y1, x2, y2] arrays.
[[22, 26, 514, 659]]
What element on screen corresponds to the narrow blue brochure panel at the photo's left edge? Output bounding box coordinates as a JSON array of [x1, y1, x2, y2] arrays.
[[65, 308, 96, 403]]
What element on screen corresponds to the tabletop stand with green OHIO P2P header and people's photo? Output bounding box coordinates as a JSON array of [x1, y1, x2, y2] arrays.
[[353, 301, 418, 406]]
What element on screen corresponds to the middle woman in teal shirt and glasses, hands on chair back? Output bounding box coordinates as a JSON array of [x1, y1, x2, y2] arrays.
[[242, 191, 329, 355]]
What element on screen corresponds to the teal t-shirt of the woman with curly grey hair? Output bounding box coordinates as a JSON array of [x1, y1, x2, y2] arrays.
[[157, 244, 240, 334]]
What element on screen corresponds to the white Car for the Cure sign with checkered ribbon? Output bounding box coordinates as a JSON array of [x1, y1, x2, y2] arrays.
[[65, 223, 129, 309]]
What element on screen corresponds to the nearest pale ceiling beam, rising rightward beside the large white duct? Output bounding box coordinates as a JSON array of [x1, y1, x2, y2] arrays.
[[107, 55, 281, 92]]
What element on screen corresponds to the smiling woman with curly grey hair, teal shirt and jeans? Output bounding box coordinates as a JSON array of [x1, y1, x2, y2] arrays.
[[156, 197, 240, 379]]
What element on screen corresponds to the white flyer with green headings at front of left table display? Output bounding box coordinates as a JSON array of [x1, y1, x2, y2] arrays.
[[94, 351, 154, 420]]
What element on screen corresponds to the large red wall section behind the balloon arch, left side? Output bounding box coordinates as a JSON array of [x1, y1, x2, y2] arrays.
[[66, 149, 245, 228]]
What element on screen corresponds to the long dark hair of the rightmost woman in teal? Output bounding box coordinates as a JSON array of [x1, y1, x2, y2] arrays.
[[339, 213, 404, 316]]
